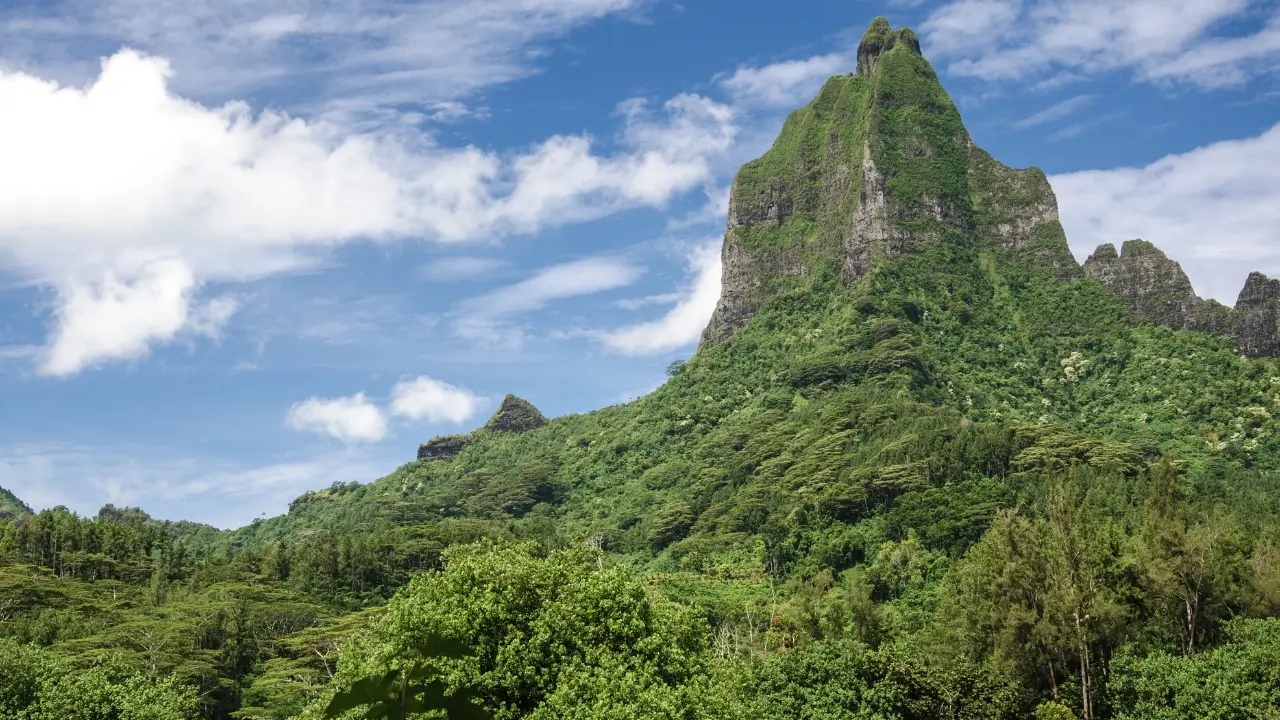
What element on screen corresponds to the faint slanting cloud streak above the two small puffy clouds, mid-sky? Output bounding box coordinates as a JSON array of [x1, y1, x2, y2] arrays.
[[453, 258, 643, 347]]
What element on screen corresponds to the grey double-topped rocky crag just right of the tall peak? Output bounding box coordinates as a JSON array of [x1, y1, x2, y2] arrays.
[[1084, 240, 1230, 333]]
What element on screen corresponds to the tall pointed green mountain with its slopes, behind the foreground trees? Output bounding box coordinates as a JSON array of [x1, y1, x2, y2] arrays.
[[242, 20, 1280, 569]]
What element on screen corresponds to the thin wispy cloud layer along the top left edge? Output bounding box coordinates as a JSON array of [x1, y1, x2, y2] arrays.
[[0, 0, 640, 123]]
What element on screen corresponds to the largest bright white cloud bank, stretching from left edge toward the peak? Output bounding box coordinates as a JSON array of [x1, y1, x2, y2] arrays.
[[0, 51, 736, 375]]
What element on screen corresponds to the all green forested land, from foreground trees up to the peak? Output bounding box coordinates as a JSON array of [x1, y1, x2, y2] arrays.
[[0, 19, 1280, 720]]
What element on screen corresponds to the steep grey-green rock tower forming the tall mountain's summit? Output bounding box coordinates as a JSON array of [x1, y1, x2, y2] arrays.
[[700, 18, 1082, 347]]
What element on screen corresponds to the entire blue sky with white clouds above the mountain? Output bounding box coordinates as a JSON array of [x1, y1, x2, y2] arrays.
[[0, 0, 1280, 528]]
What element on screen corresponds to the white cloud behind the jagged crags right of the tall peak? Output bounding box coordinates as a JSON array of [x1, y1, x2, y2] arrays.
[[1050, 126, 1280, 305]]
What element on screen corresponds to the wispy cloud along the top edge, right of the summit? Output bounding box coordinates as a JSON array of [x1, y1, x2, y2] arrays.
[[920, 0, 1280, 87]]
